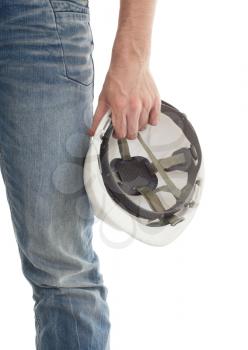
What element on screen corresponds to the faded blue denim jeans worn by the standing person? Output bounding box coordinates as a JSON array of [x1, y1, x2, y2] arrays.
[[0, 0, 110, 350]]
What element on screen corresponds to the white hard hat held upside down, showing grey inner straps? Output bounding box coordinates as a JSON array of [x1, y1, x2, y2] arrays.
[[84, 100, 203, 246]]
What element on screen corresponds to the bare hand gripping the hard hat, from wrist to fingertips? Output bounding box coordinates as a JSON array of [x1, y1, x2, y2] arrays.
[[89, 62, 161, 140]]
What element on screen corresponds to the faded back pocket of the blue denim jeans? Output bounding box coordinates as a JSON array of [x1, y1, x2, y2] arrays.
[[54, 7, 94, 86]]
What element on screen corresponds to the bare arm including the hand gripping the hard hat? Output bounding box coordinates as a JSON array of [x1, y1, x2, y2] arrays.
[[89, 0, 161, 139]]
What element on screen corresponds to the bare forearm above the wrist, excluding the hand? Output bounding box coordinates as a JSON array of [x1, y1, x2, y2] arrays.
[[111, 0, 156, 64]]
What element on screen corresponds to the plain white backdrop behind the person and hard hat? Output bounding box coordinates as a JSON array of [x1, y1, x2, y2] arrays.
[[0, 0, 248, 350]]
